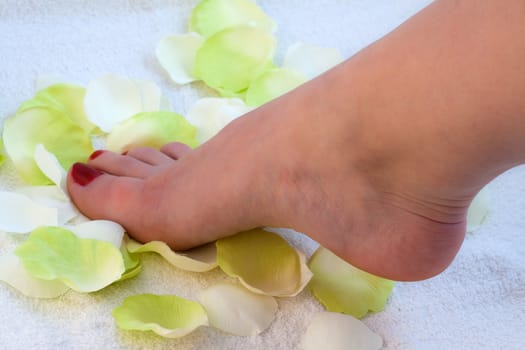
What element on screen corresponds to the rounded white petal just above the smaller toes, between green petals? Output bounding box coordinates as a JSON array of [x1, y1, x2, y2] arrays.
[[84, 74, 143, 132]]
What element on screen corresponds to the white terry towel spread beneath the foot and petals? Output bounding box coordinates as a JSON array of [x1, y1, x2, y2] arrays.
[[0, 0, 525, 349]]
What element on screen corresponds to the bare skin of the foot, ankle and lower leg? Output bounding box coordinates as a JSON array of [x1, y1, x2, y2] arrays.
[[68, 0, 525, 280]]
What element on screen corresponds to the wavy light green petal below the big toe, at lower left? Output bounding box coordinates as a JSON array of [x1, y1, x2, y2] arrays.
[[15, 227, 124, 292]]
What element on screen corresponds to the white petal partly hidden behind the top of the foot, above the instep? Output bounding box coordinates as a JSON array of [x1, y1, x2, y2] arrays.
[[186, 97, 252, 144]]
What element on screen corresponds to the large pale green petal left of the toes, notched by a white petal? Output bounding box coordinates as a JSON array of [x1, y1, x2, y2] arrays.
[[3, 107, 93, 185]]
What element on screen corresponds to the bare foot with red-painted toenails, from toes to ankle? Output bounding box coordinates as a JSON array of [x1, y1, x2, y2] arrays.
[[68, 60, 475, 280]]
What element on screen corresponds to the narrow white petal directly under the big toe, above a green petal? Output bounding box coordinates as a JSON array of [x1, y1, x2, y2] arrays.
[[66, 220, 124, 249]]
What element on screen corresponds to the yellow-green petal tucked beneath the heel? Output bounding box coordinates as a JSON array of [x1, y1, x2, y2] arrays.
[[308, 247, 394, 318]]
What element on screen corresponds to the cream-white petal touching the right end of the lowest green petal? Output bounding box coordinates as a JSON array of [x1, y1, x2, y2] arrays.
[[198, 284, 277, 336]]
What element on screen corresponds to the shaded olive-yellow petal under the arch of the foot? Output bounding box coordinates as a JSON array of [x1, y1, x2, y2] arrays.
[[216, 229, 302, 296]]
